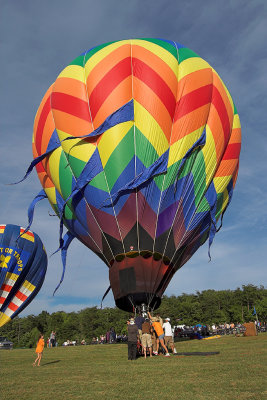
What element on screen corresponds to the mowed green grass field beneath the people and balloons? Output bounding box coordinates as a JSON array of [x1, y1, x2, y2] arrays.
[[0, 333, 267, 400]]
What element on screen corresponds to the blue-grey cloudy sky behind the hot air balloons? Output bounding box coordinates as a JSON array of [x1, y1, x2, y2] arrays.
[[0, 0, 267, 315]]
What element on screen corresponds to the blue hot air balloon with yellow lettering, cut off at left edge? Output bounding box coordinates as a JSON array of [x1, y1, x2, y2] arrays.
[[0, 224, 47, 326]]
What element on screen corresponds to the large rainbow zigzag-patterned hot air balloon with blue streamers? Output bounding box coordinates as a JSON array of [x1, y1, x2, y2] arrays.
[[27, 39, 241, 310]]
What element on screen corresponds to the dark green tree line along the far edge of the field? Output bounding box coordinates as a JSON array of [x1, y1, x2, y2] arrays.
[[0, 284, 267, 347]]
